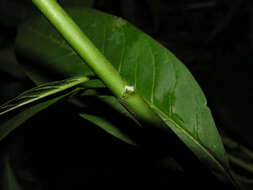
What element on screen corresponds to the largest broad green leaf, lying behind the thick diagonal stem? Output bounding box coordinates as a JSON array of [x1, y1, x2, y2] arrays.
[[16, 9, 233, 181]]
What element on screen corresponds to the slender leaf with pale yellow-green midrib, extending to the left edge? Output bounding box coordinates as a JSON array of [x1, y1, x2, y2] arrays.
[[0, 77, 87, 141]]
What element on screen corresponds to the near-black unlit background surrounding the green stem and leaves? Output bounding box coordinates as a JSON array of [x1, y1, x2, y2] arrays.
[[0, 0, 253, 189]]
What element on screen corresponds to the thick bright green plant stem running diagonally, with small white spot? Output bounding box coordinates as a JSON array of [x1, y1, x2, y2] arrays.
[[33, 0, 162, 125]]
